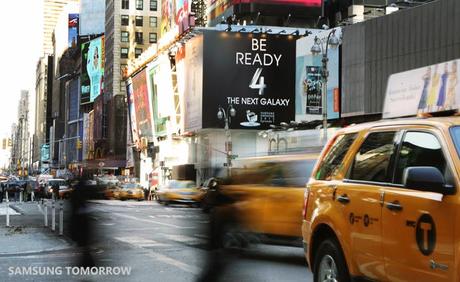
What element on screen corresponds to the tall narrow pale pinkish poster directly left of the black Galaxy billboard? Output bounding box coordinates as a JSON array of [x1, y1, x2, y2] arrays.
[[183, 36, 203, 132]]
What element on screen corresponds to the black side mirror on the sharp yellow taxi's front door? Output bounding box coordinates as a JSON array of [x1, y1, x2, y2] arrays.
[[403, 166, 455, 195]]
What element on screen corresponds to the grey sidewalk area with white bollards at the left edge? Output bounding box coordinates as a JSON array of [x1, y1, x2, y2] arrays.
[[0, 202, 74, 256]]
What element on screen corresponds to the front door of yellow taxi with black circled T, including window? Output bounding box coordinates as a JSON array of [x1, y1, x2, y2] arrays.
[[382, 131, 457, 281]]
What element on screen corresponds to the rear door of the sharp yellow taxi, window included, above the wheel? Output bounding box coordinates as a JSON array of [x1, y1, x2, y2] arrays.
[[335, 131, 397, 280]]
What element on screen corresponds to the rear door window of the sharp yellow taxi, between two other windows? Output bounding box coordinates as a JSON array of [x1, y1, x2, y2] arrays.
[[349, 132, 396, 182]]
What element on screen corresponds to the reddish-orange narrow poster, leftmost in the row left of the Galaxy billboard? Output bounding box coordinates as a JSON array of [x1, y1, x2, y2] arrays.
[[132, 70, 152, 137]]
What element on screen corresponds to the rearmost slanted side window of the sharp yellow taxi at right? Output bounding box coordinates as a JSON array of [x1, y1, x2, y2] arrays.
[[316, 133, 356, 180]]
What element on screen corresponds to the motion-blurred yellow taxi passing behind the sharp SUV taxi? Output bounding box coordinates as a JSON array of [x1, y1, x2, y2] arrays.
[[219, 153, 318, 243]]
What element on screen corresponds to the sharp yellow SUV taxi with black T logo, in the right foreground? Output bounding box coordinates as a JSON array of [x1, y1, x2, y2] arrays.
[[302, 116, 460, 281]]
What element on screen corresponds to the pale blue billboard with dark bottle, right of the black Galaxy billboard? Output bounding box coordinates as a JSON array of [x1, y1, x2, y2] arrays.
[[295, 29, 341, 121]]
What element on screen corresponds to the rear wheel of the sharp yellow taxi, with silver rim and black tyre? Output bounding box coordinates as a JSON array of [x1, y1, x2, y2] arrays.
[[314, 239, 350, 282]]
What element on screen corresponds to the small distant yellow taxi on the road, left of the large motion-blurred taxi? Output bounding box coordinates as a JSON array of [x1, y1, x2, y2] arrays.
[[156, 180, 202, 205]]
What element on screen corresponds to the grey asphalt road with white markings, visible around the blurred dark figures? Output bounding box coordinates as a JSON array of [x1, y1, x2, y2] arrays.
[[0, 201, 312, 282]]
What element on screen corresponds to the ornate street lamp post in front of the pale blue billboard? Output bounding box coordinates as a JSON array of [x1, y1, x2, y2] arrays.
[[311, 29, 340, 142]]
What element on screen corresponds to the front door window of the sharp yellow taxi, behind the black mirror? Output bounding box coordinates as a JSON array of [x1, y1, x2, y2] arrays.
[[394, 132, 451, 184]]
